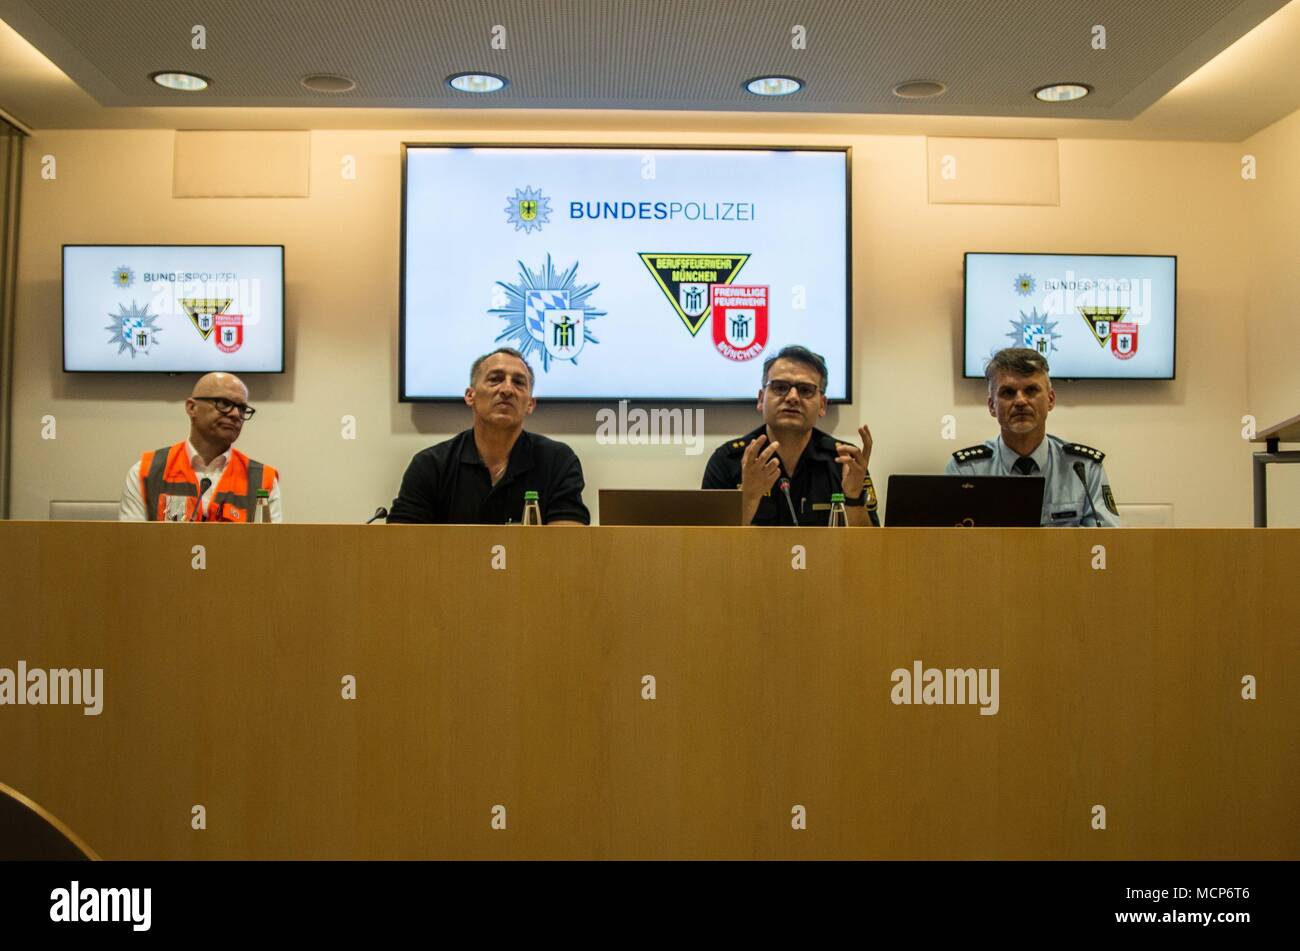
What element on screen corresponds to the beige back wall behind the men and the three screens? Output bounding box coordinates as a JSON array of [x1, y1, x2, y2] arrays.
[[13, 117, 1284, 526]]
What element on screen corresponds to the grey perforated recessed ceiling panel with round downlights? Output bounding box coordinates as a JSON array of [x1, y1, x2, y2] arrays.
[[0, 0, 1284, 118]]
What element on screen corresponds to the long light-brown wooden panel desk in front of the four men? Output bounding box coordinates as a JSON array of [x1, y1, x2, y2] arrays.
[[0, 522, 1300, 859]]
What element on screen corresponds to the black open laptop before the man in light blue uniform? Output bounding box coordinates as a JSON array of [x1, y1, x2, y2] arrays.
[[885, 476, 1044, 527]]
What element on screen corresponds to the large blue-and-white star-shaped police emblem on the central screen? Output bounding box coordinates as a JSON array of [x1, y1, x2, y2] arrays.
[[488, 255, 606, 372]]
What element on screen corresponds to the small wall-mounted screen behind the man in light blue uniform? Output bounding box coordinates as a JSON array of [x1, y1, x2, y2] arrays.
[[962, 251, 1178, 379]]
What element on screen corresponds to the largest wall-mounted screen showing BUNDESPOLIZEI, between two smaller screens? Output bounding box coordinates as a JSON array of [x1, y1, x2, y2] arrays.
[[399, 144, 853, 401]]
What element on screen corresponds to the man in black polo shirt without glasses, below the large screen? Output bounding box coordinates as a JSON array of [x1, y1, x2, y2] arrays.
[[389, 347, 592, 525]]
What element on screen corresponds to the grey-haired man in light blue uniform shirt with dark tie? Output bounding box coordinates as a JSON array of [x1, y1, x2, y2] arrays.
[[944, 347, 1119, 527]]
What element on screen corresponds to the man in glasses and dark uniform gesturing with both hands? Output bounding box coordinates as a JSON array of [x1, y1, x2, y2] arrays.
[[703, 347, 880, 525]]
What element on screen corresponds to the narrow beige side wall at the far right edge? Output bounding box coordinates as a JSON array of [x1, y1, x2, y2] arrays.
[[1238, 112, 1300, 526]]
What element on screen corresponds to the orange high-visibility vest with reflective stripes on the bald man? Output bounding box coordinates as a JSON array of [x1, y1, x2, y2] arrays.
[[140, 440, 277, 522]]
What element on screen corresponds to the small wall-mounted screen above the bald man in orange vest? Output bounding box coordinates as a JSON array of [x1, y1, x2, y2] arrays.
[[64, 244, 285, 373]]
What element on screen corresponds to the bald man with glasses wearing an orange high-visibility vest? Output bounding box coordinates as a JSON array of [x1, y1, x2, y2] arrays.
[[117, 373, 282, 522]]
